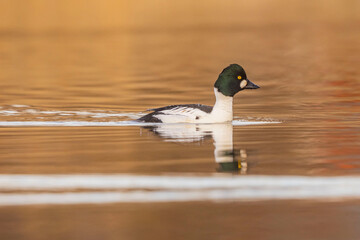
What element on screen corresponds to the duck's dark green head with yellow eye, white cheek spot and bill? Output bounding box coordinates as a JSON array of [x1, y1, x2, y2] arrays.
[[214, 64, 259, 97]]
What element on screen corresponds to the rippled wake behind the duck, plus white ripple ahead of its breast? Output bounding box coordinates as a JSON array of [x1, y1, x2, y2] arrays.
[[0, 105, 280, 127]]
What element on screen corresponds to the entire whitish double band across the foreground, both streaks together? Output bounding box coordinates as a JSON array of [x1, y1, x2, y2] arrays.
[[0, 174, 360, 205]]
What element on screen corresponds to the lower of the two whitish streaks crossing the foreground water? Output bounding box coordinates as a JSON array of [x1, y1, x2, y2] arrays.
[[0, 188, 360, 206]]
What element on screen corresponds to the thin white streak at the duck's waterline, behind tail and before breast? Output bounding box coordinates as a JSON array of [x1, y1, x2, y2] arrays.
[[0, 121, 280, 127]]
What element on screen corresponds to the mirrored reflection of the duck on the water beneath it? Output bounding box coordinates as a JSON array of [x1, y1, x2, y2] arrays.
[[145, 123, 247, 174]]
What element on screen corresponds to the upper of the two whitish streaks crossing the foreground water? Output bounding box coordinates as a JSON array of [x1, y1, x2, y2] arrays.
[[0, 174, 360, 190]]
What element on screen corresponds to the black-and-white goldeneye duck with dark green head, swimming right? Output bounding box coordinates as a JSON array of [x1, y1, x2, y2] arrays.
[[137, 64, 259, 123]]
